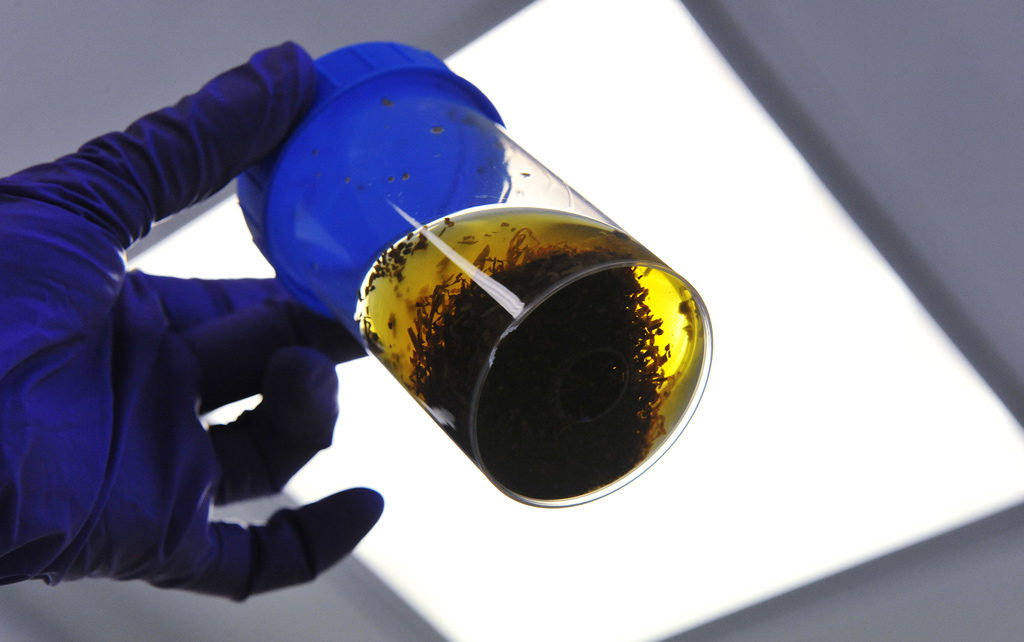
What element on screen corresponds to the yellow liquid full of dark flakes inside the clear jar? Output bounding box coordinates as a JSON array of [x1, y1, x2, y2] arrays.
[[357, 209, 710, 503]]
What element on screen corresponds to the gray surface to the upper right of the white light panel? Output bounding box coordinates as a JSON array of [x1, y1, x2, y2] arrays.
[[684, 0, 1024, 430]]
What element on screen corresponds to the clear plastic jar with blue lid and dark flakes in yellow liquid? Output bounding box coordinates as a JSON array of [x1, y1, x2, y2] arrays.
[[239, 43, 712, 506]]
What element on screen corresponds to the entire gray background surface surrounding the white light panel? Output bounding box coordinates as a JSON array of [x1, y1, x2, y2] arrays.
[[0, 0, 1024, 640]]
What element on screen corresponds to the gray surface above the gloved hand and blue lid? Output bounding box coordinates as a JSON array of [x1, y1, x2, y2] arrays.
[[0, 0, 529, 255]]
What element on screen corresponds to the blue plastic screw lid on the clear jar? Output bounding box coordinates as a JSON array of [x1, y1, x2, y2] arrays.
[[238, 42, 512, 320]]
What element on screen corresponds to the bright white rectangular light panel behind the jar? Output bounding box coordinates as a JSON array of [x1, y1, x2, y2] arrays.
[[136, 0, 1024, 642]]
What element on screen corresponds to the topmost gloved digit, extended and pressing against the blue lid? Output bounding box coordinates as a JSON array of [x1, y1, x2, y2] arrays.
[[3, 43, 316, 249]]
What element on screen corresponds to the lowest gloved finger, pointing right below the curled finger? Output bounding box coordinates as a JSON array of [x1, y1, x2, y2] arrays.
[[167, 488, 384, 601]]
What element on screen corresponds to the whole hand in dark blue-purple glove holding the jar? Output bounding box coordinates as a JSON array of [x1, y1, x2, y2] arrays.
[[0, 44, 382, 599]]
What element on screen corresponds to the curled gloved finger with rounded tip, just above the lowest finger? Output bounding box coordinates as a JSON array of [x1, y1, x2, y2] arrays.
[[210, 346, 338, 504]]
